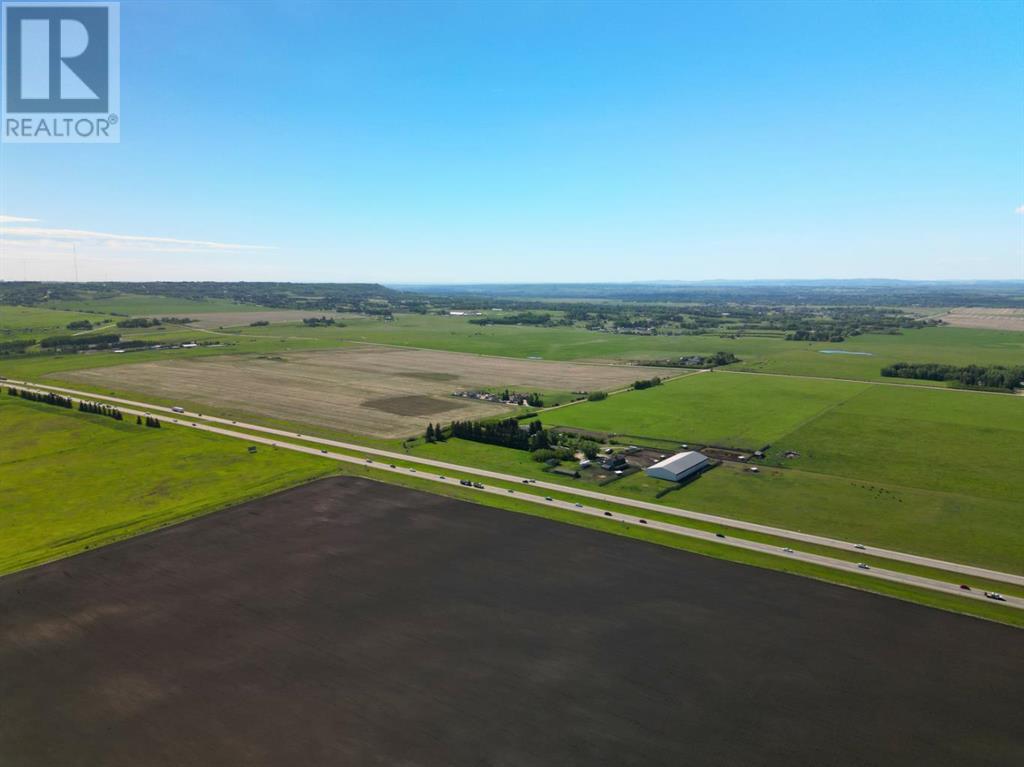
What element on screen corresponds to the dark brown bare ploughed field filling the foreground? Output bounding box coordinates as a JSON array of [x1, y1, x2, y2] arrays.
[[0, 478, 1024, 767]]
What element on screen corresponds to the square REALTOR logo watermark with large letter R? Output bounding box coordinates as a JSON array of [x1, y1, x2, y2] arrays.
[[0, 3, 121, 143]]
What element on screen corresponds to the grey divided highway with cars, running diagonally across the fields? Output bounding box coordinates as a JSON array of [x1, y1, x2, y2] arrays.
[[5, 380, 1024, 609]]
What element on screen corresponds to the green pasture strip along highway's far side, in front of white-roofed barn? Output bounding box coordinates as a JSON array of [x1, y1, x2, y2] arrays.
[[411, 439, 1024, 573]]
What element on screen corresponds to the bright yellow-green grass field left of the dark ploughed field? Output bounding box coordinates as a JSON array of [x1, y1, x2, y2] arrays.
[[0, 393, 335, 573]]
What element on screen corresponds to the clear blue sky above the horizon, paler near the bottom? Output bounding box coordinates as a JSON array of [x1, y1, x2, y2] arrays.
[[0, 1, 1024, 283]]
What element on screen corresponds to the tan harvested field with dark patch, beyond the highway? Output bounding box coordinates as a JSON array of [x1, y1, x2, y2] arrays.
[[61, 346, 663, 437]]
